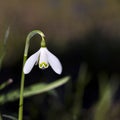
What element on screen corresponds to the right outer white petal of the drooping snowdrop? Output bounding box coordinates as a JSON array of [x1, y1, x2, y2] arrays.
[[46, 48, 62, 74]]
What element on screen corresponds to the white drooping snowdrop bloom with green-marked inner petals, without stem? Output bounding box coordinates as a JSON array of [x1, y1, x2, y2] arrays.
[[23, 47, 62, 74]]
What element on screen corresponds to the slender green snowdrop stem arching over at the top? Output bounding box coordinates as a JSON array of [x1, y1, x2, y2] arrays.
[[18, 30, 46, 120]]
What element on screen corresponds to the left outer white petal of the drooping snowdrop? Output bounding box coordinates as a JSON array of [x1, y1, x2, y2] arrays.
[[23, 50, 40, 74]]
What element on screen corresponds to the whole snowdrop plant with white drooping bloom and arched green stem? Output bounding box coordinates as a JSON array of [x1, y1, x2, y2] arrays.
[[18, 30, 62, 120]]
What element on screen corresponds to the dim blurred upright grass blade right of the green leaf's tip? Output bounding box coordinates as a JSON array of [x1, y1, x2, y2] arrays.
[[72, 63, 90, 120]]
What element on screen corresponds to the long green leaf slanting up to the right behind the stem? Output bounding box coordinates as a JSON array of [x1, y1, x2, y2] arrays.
[[0, 76, 70, 104]]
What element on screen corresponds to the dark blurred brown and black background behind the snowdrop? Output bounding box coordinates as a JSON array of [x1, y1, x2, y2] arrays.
[[0, 0, 120, 120]]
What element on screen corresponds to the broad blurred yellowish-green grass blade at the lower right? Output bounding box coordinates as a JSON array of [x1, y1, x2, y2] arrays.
[[94, 74, 120, 120]]
